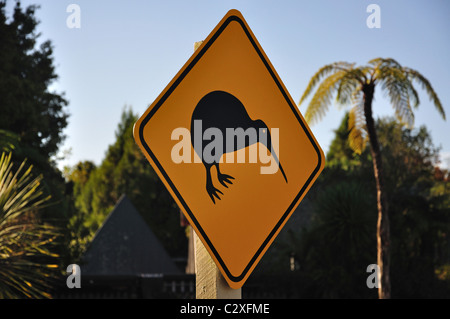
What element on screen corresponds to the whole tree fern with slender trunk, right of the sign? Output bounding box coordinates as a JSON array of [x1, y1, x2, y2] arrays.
[[299, 58, 445, 298]]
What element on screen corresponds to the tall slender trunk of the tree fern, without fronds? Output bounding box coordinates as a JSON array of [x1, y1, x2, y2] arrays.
[[363, 83, 391, 299]]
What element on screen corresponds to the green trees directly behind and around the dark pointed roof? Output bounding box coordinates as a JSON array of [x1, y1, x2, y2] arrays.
[[68, 109, 187, 257]]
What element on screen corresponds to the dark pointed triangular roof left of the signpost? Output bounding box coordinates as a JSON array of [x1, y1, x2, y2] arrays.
[[81, 195, 180, 276]]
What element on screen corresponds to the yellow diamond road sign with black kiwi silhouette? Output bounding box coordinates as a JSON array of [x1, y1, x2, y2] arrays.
[[134, 10, 325, 288]]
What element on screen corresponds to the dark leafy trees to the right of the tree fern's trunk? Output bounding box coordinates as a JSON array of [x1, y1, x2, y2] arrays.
[[379, 121, 450, 298]]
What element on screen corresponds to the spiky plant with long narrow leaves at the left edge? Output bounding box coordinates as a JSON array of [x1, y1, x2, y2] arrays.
[[0, 153, 58, 298]]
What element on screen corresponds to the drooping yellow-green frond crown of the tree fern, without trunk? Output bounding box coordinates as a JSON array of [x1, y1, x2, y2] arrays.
[[299, 58, 445, 135]]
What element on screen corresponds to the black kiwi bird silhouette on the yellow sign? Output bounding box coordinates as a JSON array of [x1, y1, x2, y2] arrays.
[[191, 91, 287, 204]]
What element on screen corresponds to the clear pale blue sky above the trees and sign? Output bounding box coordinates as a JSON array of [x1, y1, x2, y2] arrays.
[[4, 0, 450, 167]]
